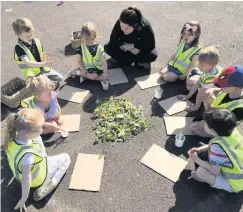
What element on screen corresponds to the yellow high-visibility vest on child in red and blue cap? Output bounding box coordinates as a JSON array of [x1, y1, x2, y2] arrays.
[[211, 92, 243, 111]]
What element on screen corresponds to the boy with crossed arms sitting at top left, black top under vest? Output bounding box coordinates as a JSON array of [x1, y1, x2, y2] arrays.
[[12, 18, 63, 82]]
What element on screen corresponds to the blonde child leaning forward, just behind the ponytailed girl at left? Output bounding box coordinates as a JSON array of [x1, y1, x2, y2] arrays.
[[21, 76, 62, 134]]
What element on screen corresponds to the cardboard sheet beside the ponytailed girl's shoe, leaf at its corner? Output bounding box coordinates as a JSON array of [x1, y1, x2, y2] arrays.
[[69, 153, 104, 191]]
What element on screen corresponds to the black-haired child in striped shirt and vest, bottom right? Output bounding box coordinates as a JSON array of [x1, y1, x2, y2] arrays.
[[188, 108, 243, 192]]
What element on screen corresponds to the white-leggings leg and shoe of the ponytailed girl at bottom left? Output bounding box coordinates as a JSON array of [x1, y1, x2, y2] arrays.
[[33, 153, 71, 201]]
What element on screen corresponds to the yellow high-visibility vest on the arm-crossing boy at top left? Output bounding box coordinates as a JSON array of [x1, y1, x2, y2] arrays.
[[14, 38, 50, 78]]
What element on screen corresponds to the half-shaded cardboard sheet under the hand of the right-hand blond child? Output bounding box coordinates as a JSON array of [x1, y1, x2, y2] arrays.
[[158, 96, 192, 115]]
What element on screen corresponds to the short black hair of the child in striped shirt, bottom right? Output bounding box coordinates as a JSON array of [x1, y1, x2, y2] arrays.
[[203, 108, 237, 136]]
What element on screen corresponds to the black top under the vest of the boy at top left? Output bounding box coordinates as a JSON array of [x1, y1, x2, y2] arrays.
[[15, 39, 43, 62]]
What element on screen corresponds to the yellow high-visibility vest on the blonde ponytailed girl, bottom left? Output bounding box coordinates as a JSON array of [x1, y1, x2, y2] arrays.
[[6, 141, 47, 188]]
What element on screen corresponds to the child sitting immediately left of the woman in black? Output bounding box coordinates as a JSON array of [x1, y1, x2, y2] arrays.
[[68, 22, 108, 83]]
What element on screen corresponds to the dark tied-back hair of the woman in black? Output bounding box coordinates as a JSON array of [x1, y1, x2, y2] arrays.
[[119, 7, 143, 28]]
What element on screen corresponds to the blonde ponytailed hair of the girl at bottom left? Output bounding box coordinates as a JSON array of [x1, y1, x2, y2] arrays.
[[3, 108, 45, 151]]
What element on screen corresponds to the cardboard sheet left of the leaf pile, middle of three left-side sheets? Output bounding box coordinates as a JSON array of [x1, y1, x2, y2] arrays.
[[60, 114, 81, 132]]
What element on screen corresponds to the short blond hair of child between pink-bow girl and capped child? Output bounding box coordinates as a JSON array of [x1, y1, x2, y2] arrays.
[[198, 46, 220, 65]]
